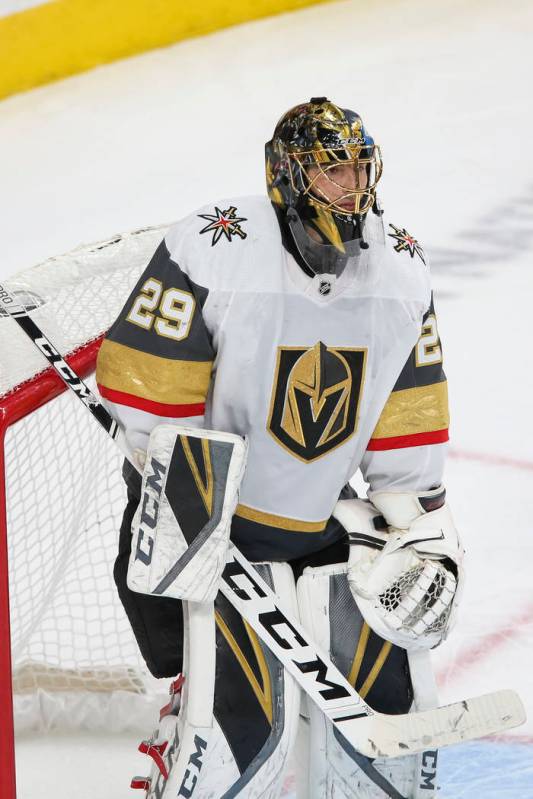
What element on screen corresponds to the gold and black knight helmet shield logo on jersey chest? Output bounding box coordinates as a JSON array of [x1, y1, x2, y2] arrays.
[[268, 341, 366, 462]]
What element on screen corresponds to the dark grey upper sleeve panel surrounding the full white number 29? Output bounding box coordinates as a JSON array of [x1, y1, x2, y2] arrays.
[[106, 241, 215, 361]]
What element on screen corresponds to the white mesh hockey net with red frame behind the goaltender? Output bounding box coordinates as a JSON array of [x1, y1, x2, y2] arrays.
[[0, 228, 166, 752]]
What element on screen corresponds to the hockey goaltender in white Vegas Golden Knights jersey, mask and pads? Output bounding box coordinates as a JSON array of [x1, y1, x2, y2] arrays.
[[97, 97, 462, 799]]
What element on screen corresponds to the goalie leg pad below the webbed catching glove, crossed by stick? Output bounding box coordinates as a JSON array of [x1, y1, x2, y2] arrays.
[[297, 564, 436, 799]]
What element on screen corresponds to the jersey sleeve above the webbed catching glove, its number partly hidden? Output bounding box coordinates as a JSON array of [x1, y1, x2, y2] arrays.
[[361, 299, 449, 491]]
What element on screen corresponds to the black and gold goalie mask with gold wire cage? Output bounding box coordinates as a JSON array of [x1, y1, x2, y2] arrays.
[[265, 97, 382, 276]]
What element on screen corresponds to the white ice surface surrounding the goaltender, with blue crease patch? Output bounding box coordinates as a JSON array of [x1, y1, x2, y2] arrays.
[[0, 0, 533, 799]]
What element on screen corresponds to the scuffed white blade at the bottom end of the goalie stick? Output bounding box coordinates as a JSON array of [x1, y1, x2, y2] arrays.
[[336, 690, 526, 758]]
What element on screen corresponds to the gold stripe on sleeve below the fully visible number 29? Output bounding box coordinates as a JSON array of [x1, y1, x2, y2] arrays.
[[96, 339, 213, 405]]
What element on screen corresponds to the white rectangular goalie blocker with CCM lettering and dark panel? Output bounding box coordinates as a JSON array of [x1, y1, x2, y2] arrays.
[[128, 424, 247, 602]]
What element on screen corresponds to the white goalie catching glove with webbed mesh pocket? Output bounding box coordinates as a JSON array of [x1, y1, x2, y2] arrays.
[[334, 488, 463, 650]]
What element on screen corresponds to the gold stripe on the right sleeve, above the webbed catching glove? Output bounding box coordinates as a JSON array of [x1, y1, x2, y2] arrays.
[[372, 380, 450, 438]]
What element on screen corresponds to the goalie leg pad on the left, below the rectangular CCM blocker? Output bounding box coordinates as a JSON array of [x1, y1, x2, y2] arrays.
[[140, 563, 300, 799]]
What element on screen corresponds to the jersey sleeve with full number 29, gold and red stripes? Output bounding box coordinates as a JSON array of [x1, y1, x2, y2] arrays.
[[96, 241, 215, 449]]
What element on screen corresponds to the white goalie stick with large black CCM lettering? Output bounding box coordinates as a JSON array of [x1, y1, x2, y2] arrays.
[[0, 285, 525, 758]]
